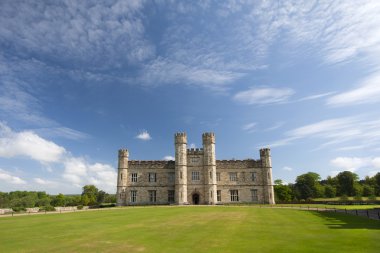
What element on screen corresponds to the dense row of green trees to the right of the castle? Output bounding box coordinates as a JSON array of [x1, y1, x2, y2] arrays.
[[274, 171, 380, 202]]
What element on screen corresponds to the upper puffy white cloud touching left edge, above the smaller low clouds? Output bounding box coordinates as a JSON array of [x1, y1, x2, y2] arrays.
[[0, 122, 66, 162]]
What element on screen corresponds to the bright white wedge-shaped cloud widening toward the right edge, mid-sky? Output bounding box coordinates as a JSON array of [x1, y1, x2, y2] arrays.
[[327, 71, 380, 106]]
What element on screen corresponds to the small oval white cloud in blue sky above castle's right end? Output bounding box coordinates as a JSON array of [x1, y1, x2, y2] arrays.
[[233, 87, 295, 105]]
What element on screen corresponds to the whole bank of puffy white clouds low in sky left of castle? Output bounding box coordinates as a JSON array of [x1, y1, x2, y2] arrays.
[[0, 123, 117, 192]]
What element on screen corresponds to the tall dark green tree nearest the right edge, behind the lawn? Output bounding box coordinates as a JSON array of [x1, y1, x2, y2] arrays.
[[336, 171, 361, 196]]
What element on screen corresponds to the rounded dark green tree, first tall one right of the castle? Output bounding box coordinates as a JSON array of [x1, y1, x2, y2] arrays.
[[294, 172, 321, 200]]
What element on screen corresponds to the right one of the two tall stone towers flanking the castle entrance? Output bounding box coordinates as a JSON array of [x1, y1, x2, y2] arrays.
[[202, 133, 217, 205]]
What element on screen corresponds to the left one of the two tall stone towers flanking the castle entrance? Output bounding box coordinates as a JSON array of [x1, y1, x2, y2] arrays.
[[174, 133, 188, 205]]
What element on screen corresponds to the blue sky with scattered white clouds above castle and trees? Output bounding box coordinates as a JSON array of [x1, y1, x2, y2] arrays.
[[0, 0, 380, 193]]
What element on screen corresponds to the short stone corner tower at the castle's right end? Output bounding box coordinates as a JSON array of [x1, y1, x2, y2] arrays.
[[260, 148, 275, 205]]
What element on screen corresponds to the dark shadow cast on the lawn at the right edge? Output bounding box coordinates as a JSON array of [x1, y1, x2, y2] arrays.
[[305, 211, 380, 230]]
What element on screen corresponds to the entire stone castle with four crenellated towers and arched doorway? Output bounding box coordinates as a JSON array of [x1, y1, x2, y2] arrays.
[[116, 133, 274, 205]]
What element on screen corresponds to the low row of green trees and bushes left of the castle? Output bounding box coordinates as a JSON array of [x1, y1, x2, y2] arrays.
[[0, 185, 116, 211]]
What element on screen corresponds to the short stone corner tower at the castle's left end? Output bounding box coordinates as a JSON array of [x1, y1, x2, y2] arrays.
[[116, 149, 129, 206]]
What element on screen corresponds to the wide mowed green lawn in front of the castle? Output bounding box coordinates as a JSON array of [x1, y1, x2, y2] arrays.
[[0, 206, 380, 253]]
